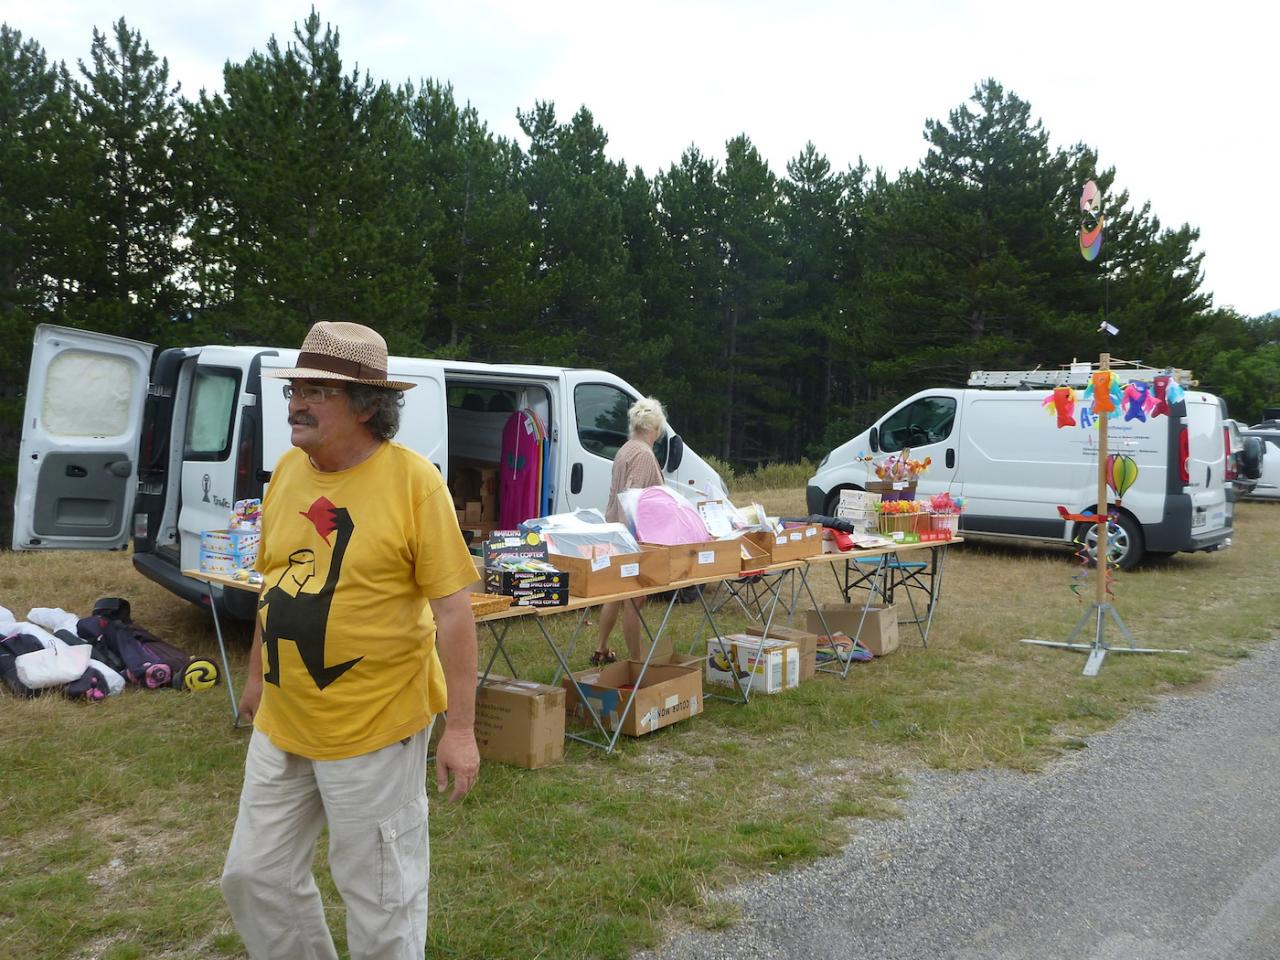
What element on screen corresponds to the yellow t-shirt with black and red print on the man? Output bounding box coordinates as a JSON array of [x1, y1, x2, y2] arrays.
[[253, 442, 476, 760]]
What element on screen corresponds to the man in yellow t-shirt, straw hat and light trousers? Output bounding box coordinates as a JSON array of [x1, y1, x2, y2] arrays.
[[223, 323, 480, 960]]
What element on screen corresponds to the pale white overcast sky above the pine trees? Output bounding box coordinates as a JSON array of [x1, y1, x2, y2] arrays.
[[10, 0, 1280, 315]]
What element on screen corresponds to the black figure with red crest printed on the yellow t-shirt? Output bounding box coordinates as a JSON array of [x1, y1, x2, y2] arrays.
[[259, 497, 364, 690]]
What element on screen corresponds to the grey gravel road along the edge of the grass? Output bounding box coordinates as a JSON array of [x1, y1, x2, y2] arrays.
[[637, 641, 1280, 960]]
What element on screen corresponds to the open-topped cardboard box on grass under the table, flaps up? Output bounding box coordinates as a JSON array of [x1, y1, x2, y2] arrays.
[[561, 660, 703, 737]]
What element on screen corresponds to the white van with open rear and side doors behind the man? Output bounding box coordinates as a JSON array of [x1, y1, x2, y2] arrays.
[[13, 325, 723, 616]]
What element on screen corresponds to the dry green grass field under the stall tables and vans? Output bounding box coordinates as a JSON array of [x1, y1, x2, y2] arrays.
[[0, 489, 1280, 960]]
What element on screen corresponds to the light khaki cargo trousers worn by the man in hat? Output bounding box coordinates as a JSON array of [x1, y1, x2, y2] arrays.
[[223, 727, 430, 960]]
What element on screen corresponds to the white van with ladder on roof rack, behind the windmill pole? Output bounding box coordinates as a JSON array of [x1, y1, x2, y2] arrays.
[[806, 370, 1233, 568]]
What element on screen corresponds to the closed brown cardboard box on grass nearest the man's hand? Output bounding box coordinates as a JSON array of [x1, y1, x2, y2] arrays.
[[476, 673, 564, 771]]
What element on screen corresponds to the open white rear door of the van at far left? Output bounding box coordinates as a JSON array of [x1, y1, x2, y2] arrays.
[[13, 324, 155, 550]]
